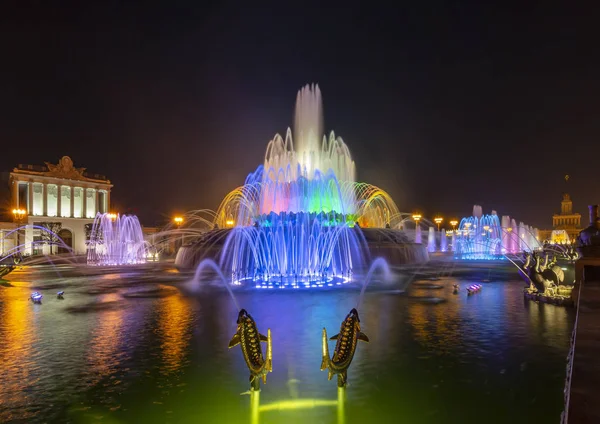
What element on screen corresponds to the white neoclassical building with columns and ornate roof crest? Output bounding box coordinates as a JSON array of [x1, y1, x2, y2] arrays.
[[9, 156, 112, 255]]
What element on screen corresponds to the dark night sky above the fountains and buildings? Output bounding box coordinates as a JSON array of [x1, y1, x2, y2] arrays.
[[0, 1, 600, 227]]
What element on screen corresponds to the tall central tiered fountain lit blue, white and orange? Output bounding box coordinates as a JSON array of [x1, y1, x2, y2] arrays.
[[176, 86, 427, 288]]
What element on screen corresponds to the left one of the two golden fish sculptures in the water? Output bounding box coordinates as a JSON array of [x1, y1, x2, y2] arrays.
[[229, 309, 273, 391]]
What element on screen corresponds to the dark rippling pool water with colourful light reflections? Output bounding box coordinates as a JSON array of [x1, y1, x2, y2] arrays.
[[0, 270, 573, 424]]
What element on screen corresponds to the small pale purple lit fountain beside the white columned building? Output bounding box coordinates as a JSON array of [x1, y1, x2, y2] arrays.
[[87, 213, 148, 266]]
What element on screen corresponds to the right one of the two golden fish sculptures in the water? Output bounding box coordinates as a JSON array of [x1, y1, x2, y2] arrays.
[[321, 308, 369, 387]]
